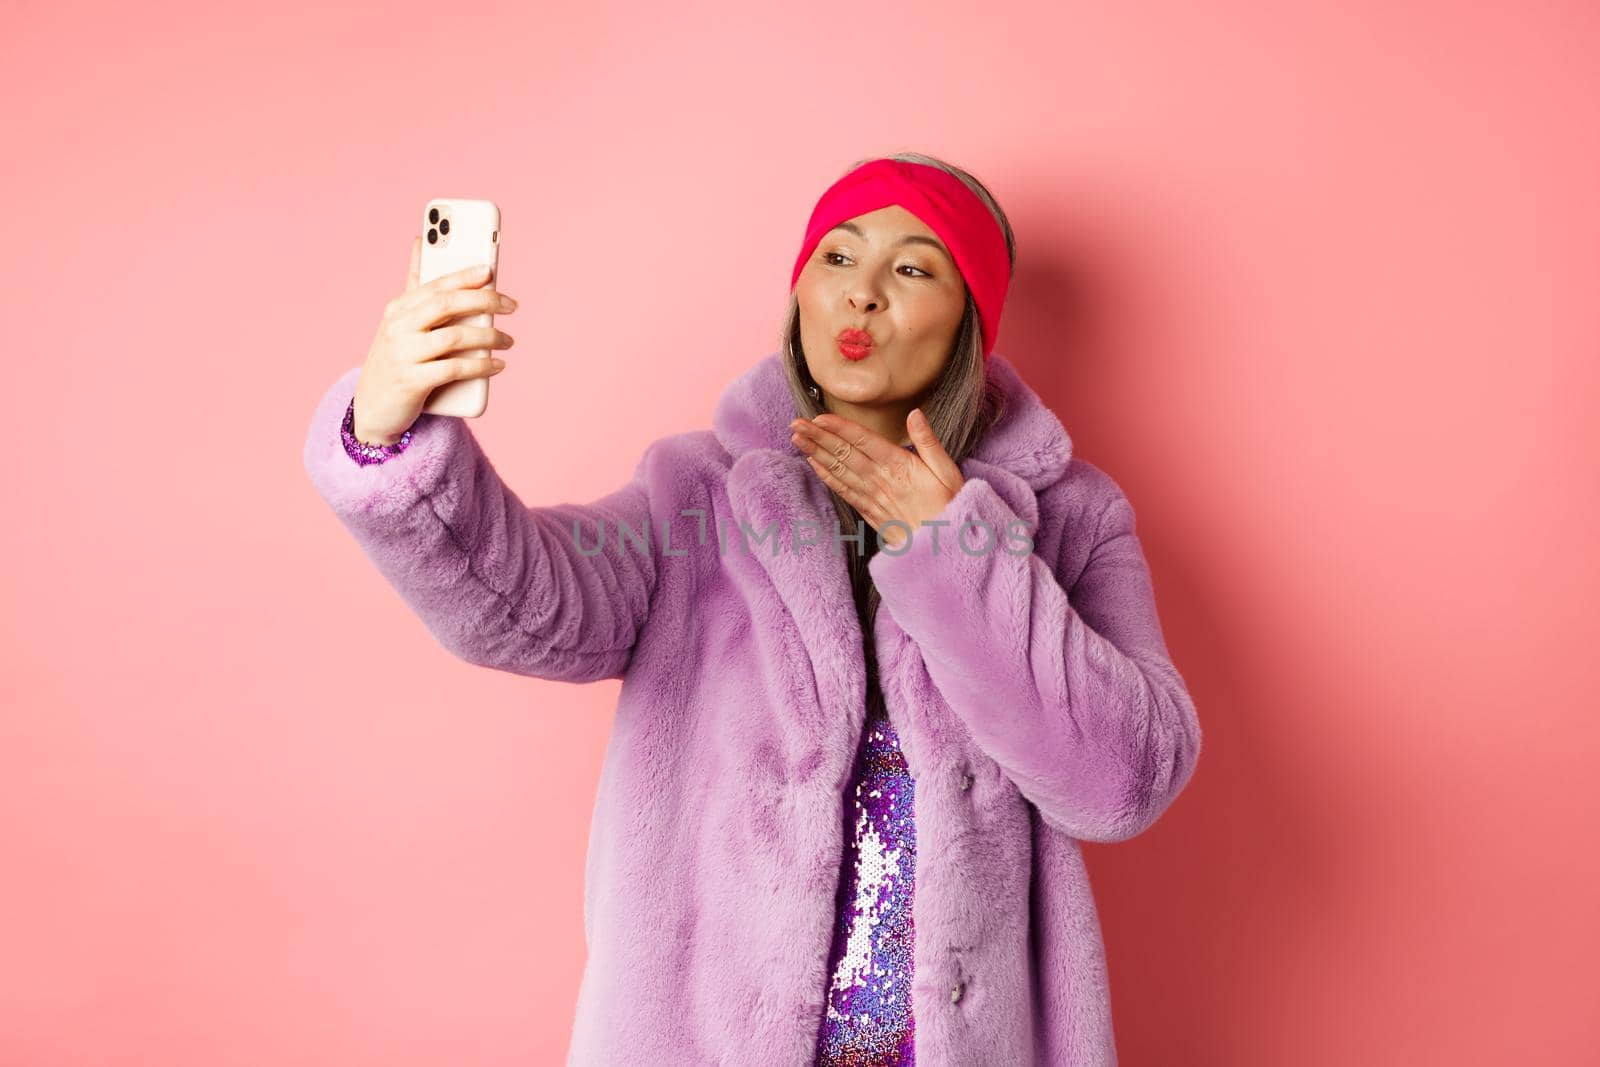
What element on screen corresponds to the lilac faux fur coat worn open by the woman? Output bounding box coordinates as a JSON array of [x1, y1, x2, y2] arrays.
[[304, 354, 1200, 1067]]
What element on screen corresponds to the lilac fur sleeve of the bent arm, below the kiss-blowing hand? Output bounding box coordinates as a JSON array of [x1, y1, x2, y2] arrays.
[[869, 478, 1200, 841]]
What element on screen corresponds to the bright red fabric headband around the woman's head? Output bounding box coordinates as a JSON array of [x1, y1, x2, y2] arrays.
[[789, 160, 1011, 358]]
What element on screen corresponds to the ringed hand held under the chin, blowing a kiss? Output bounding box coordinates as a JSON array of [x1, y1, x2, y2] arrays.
[[789, 408, 966, 547]]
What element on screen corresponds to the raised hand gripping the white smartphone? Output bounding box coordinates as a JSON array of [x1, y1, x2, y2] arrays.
[[354, 237, 517, 445]]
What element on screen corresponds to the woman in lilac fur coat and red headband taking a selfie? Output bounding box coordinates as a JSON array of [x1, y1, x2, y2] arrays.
[[306, 154, 1200, 1067]]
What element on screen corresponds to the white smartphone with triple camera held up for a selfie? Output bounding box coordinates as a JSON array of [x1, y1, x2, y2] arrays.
[[418, 197, 499, 419]]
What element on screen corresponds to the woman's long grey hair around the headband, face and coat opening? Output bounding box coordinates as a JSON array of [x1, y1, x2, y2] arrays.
[[779, 152, 1016, 699]]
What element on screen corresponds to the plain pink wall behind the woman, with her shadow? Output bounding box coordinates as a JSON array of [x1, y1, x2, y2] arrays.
[[0, 0, 1600, 1067]]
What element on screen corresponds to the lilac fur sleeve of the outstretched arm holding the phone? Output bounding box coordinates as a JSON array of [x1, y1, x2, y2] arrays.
[[302, 368, 659, 681]]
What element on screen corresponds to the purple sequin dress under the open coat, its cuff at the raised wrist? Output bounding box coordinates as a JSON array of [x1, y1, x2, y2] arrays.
[[341, 400, 917, 1067]]
